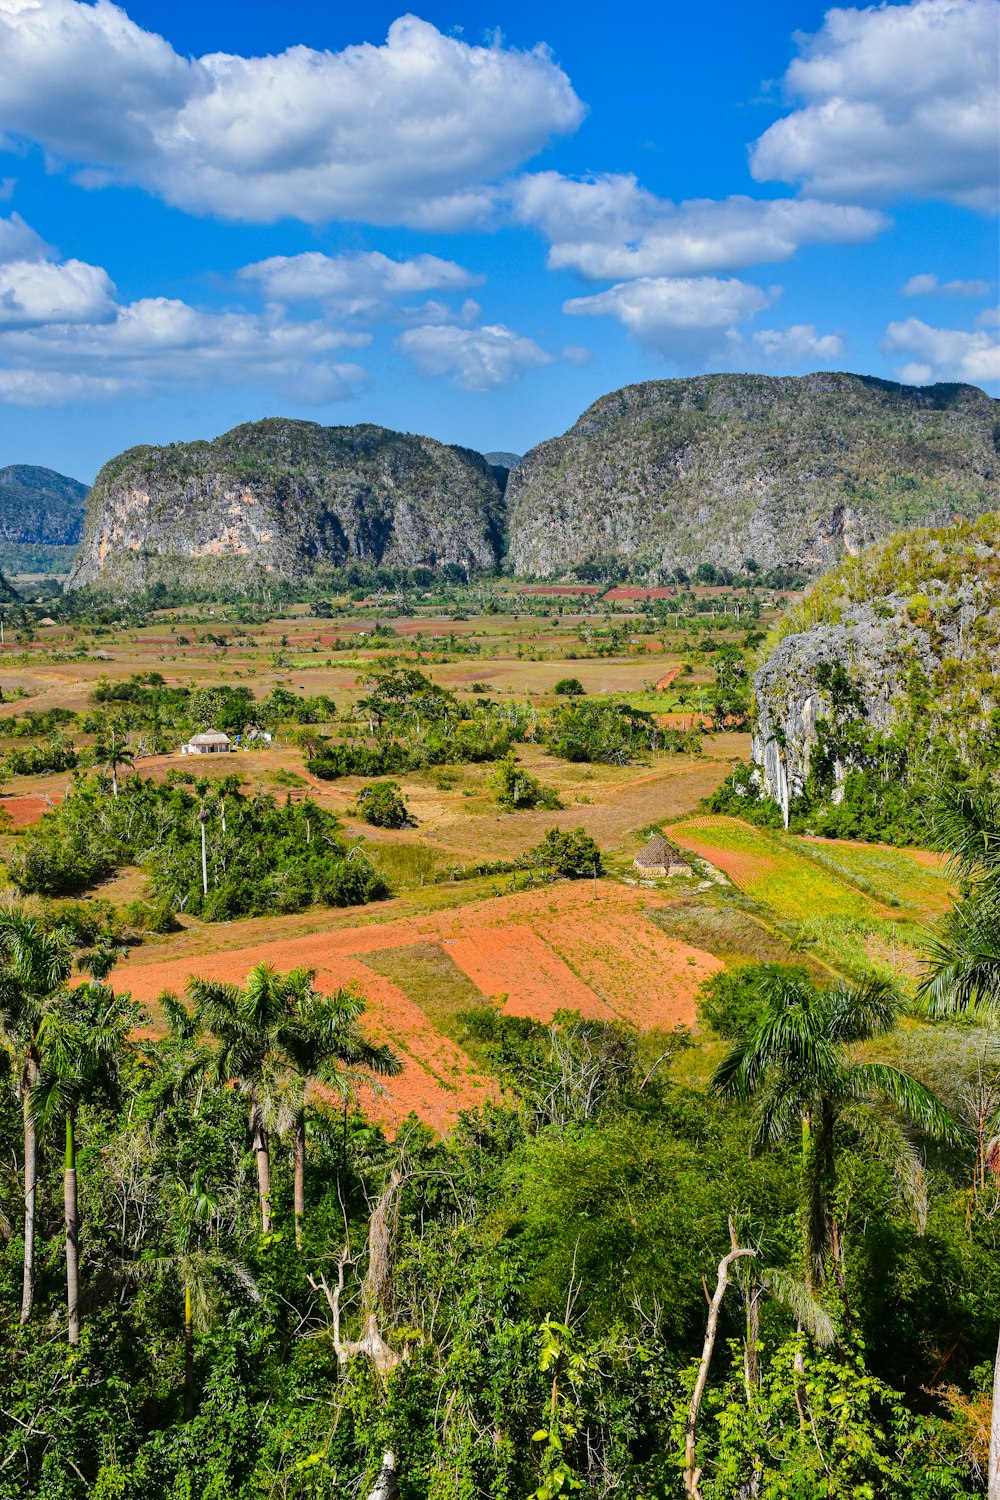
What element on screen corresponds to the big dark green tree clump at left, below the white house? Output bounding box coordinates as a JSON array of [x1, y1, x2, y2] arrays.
[[7, 780, 388, 921]]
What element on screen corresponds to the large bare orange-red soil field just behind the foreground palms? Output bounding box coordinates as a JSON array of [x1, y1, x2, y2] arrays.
[[115, 881, 723, 1130]]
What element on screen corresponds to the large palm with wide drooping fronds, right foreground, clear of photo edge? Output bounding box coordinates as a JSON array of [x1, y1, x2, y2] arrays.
[[709, 978, 960, 1292]]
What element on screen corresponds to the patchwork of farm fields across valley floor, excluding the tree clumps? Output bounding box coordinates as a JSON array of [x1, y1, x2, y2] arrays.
[[0, 573, 948, 1131]]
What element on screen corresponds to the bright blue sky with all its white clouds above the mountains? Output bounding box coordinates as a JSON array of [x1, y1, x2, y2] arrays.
[[0, 0, 1000, 480]]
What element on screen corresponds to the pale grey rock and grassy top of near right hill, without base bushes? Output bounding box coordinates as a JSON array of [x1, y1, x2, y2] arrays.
[[753, 515, 1000, 824]]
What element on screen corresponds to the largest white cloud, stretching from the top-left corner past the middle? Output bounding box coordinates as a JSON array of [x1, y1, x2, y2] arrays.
[[0, 0, 583, 228]]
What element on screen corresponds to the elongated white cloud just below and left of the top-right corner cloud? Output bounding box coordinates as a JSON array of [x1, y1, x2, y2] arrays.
[[513, 173, 888, 281]]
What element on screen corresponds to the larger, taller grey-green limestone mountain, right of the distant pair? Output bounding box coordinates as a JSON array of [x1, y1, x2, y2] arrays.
[[507, 374, 1000, 576]]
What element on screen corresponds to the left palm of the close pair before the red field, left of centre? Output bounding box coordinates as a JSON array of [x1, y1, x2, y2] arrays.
[[187, 963, 285, 1235]]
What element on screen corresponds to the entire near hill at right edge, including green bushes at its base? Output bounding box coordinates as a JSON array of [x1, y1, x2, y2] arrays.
[[715, 515, 1000, 843]]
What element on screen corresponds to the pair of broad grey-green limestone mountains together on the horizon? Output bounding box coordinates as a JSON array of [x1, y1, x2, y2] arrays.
[[9, 374, 1000, 594]]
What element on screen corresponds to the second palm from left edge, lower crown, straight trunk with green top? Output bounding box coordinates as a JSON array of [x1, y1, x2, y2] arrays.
[[31, 980, 138, 1344]]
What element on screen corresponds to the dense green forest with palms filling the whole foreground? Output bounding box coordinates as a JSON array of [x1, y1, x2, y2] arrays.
[[0, 792, 1000, 1500]]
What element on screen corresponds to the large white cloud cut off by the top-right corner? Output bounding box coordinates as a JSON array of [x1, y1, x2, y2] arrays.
[[750, 0, 1000, 209]]
